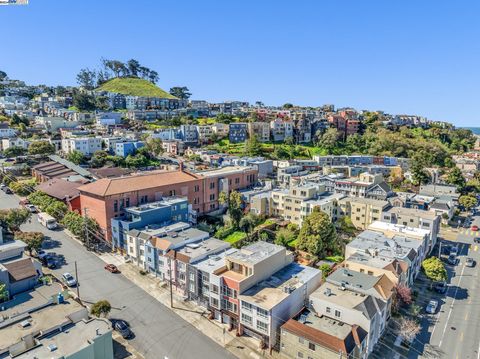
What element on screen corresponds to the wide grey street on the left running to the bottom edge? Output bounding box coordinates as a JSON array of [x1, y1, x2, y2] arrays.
[[0, 191, 233, 359]]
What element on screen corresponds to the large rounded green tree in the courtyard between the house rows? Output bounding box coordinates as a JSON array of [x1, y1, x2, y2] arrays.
[[297, 208, 338, 257]]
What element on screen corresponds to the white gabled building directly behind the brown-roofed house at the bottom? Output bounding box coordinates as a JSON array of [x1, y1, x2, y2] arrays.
[[310, 282, 388, 355]]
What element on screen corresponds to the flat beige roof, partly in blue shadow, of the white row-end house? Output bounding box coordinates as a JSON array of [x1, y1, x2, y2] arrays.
[[238, 263, 321, 310]]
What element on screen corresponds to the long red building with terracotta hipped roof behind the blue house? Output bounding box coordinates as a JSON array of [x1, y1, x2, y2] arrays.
[[79, 167, 257, 241]]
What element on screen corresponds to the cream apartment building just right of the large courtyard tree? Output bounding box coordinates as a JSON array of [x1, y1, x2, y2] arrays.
[[338, 197, 390, 229]]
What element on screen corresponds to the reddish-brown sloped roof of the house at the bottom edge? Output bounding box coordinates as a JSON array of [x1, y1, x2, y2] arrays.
[[282, 319, 359, 354]]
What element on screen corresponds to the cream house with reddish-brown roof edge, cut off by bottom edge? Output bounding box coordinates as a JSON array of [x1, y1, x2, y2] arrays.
[[280, 309, 368, 359]]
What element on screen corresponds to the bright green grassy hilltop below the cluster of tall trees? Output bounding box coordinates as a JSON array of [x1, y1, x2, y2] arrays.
[[97, 77, 176, 99]]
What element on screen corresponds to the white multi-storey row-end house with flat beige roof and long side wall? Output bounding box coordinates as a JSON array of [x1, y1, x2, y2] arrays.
[[238, 263, 322, 348]]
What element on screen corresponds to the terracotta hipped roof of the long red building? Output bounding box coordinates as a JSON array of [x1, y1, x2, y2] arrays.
[[79, 171, 198, 196]]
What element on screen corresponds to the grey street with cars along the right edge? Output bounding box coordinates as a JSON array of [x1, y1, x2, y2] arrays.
[[409, 207, 480, 359]]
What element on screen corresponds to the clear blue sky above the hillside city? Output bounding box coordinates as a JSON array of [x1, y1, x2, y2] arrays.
[[0, 0, 480, 126]]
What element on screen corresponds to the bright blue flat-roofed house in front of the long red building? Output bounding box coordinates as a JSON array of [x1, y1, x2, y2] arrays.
[[111, 197, 189, 251]]
